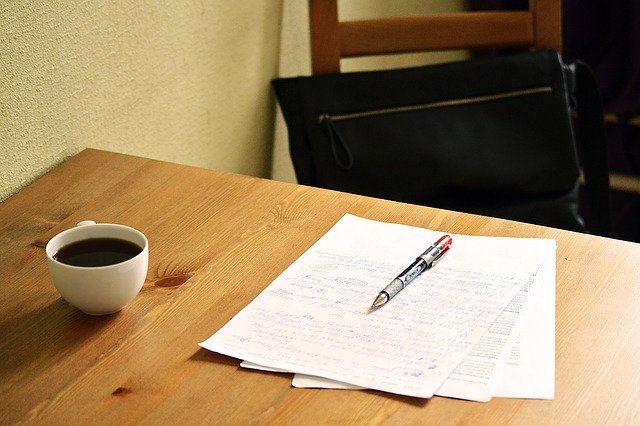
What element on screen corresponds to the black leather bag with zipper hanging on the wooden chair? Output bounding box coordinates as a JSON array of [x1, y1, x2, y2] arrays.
[[273, 52, 608, 234]]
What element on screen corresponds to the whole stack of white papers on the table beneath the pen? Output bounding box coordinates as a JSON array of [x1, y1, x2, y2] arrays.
[[200, 215, 556, 401]]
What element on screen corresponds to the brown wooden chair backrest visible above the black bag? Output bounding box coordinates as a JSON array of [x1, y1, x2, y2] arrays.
[[309, 0, 562, 75]]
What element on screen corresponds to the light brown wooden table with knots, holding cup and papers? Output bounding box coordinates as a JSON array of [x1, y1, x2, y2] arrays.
[[0, 150, 640, 424]]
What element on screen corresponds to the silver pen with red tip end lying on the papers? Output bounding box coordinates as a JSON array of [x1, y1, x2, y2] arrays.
[[371, 235, 453, 308]]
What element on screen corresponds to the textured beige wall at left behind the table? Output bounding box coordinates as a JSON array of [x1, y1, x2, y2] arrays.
[[0, 0, 281, 200]]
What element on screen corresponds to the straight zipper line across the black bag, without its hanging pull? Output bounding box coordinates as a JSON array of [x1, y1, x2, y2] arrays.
[[318, 86, 553, 123]]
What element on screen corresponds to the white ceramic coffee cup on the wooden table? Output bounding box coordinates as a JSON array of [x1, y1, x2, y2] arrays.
[[46, 221, 149, 315]]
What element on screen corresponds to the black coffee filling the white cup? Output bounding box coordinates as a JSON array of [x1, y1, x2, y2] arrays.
[[53, 238, 142, 266]]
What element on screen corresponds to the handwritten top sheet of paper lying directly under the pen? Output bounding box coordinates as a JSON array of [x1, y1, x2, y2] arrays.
[[201, 215, 555, 397]]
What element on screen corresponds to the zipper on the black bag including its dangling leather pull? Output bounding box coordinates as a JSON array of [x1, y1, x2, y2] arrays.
[[317, 86, 553, 170]]
